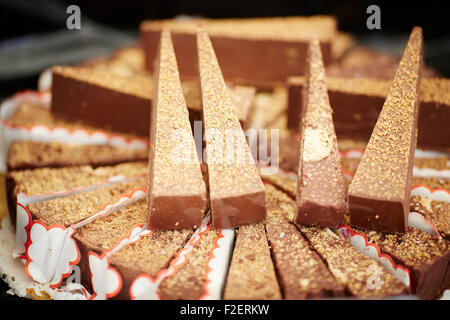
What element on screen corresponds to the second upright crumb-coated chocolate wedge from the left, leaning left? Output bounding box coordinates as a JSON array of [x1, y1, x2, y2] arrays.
[[197, 31, 266, 229]]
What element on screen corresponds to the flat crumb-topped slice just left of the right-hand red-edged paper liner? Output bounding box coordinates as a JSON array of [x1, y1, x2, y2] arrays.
[[300, 227, 409, 298]]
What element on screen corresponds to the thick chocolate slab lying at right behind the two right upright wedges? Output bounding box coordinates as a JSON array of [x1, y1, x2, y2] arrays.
[[287, 77, 450, 150]]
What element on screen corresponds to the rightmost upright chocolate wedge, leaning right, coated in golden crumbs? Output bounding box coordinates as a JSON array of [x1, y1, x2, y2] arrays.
[[348, 27, 423, 233]]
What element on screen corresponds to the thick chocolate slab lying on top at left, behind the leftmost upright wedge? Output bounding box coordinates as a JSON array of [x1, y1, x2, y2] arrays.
[[51, 67, 254, 137]]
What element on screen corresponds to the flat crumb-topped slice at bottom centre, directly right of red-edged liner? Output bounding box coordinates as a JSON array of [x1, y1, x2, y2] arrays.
[[224, 223, 281, 300]]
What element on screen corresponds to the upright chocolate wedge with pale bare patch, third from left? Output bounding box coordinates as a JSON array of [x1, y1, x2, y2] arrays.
[[294, 41, 347, 228]]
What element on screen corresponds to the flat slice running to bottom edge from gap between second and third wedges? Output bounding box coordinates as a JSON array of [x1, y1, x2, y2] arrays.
[[266, 185, 344, 299]]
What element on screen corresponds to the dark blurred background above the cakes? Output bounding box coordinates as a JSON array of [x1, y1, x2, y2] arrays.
[[0, 0, 450, 98]]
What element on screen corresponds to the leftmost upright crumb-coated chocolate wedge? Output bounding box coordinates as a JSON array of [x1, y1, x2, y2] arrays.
[[148, 31, 206, 230]]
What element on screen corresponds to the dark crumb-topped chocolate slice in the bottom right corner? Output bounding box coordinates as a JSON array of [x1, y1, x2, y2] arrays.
[[365, 228, 450, 299]]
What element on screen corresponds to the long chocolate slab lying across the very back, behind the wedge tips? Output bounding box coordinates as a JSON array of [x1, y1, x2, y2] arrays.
[[140, 16, 336, 87]]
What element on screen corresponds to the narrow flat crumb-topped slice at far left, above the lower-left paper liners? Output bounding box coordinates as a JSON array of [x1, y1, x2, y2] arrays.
[[6, 162, 148, 224]]
